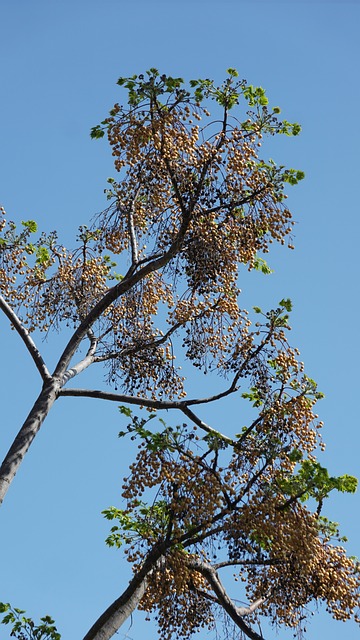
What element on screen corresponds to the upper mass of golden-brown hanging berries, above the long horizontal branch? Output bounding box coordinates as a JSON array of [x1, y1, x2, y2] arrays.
[[0, 76, 291, 398]]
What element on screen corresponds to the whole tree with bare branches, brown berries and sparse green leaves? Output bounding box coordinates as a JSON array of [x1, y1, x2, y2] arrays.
[[0, 69, 360, 640]]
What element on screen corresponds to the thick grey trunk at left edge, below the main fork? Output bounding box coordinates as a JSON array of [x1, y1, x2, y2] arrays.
[[0, 379, 60, 504]]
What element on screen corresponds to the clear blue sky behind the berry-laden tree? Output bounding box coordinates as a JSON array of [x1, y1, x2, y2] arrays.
[[0, 0, 360, 640]]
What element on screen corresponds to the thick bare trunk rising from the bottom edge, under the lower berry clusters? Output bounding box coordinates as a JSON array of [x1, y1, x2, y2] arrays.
[[83, 550, 163, 640]]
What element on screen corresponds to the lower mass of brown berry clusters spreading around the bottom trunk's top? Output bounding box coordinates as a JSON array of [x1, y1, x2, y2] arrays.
[[115, 420, 360, 640]]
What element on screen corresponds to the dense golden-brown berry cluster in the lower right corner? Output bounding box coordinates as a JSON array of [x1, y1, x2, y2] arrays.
[[242, 503, 360, 627]]
